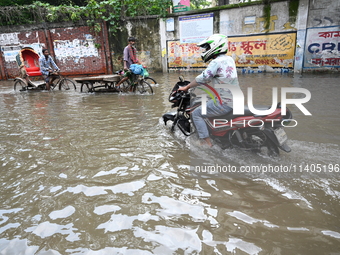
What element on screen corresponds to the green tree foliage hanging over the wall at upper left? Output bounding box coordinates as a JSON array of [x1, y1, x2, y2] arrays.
[[0, 0, 172, 31]]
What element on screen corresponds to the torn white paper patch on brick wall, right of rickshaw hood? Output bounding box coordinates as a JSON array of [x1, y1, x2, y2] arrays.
[[53, 35, 99, 62]]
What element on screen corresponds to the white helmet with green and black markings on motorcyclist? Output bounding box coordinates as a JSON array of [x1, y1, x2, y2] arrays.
[[197, 34, 228, 62]]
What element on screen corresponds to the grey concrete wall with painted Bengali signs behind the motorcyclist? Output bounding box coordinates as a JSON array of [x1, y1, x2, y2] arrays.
[[160, 0, 340, 72]]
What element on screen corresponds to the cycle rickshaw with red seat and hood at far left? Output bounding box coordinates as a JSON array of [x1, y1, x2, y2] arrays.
[[14, 47, 76, 91]]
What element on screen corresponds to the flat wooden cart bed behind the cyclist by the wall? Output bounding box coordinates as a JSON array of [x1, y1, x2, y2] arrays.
[[74, 74, 122, 93]]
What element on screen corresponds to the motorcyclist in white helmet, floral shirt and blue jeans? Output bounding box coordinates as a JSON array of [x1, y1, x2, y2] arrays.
[[178, 34, 239, 147]]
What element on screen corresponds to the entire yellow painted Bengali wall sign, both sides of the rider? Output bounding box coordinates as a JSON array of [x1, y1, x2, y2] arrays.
[[168, 33, 296, 68]]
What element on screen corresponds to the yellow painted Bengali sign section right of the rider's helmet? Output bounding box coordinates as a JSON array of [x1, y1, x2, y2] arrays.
[[228, 33, 296, 68]]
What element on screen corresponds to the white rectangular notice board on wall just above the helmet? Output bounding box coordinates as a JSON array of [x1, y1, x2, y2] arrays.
[[179, 13, 214, 43]]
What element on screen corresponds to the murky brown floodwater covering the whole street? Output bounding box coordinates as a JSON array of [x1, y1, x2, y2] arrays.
[[0, 73, 340, 255]]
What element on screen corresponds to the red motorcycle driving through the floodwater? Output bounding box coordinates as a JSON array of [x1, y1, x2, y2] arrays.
[[163, 77, 292, 156]]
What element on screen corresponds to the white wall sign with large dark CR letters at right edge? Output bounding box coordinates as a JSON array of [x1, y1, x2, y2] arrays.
[[303, 26, 340, 68]]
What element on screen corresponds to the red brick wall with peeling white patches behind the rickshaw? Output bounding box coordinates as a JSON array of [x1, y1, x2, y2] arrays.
[[0, 24, 112, 79]]
